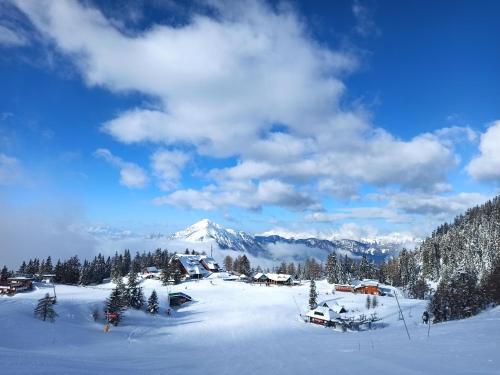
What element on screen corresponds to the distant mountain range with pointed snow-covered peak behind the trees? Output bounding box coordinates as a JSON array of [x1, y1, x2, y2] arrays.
[[170, 219, 414, 263]]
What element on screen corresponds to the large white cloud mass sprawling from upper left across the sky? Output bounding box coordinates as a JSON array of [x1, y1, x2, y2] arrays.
[[16, 0, 464, 213]]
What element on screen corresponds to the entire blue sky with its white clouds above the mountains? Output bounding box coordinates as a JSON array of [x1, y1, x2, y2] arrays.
[[0, 0, 500, 264]]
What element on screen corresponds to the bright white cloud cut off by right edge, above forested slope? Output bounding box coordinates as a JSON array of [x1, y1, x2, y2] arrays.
[[467, 121, 500, 182]]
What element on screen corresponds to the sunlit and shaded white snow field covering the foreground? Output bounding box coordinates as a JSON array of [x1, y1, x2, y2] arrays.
[[0, 279, 500, 375]]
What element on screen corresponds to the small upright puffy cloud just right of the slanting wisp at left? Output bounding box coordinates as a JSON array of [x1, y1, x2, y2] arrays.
[[151, 150, 190, 190]]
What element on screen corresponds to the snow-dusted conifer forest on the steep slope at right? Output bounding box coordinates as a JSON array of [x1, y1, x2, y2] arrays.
[[386, 197, 500, 322]]
